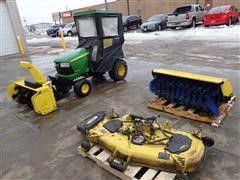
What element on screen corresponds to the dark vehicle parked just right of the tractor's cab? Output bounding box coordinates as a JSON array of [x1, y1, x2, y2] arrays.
[[122, 16, 142, 32]]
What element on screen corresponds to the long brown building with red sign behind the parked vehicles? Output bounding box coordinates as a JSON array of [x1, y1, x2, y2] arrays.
[[62, 0, 240, 23]]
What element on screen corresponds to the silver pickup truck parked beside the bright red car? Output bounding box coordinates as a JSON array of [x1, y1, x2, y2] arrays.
[[167, 4, 206, 29]]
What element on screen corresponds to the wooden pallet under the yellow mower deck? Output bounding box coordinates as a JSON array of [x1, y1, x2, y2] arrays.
[[78, 145, 176, 180]]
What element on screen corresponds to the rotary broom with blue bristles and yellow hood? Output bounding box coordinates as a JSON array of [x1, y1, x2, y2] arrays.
[[149, 69, 232, 116]]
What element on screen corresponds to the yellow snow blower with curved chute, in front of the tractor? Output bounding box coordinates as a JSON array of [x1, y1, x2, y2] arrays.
[[7, 61, 57, 115]]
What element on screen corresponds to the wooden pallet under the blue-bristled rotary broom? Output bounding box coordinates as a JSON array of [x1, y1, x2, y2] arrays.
[[148, 96, 236, 127]]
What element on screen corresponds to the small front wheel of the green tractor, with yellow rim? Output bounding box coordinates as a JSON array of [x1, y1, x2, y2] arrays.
[[74, 79, 92, 97]]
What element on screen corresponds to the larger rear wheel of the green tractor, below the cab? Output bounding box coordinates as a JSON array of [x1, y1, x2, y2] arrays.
[[108, 59, 128, 81]]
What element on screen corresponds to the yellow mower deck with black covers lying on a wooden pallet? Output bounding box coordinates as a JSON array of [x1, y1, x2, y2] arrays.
[[77, 112, 214, 179]]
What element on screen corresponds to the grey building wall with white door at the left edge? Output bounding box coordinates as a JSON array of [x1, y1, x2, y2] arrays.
[[0, 0, 27, 56]]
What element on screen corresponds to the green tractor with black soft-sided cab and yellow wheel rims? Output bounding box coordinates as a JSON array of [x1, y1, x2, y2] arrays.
[[49, 10, 128, 97]]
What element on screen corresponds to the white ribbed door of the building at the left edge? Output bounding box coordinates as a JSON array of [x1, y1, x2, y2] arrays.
[[0, 0, 19, 56]]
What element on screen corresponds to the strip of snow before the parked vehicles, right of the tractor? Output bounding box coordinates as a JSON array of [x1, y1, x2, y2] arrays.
[[124, 25, 240, 41]]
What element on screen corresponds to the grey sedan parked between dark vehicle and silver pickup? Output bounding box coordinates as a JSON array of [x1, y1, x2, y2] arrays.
[[141, 14, 168, 32]]
